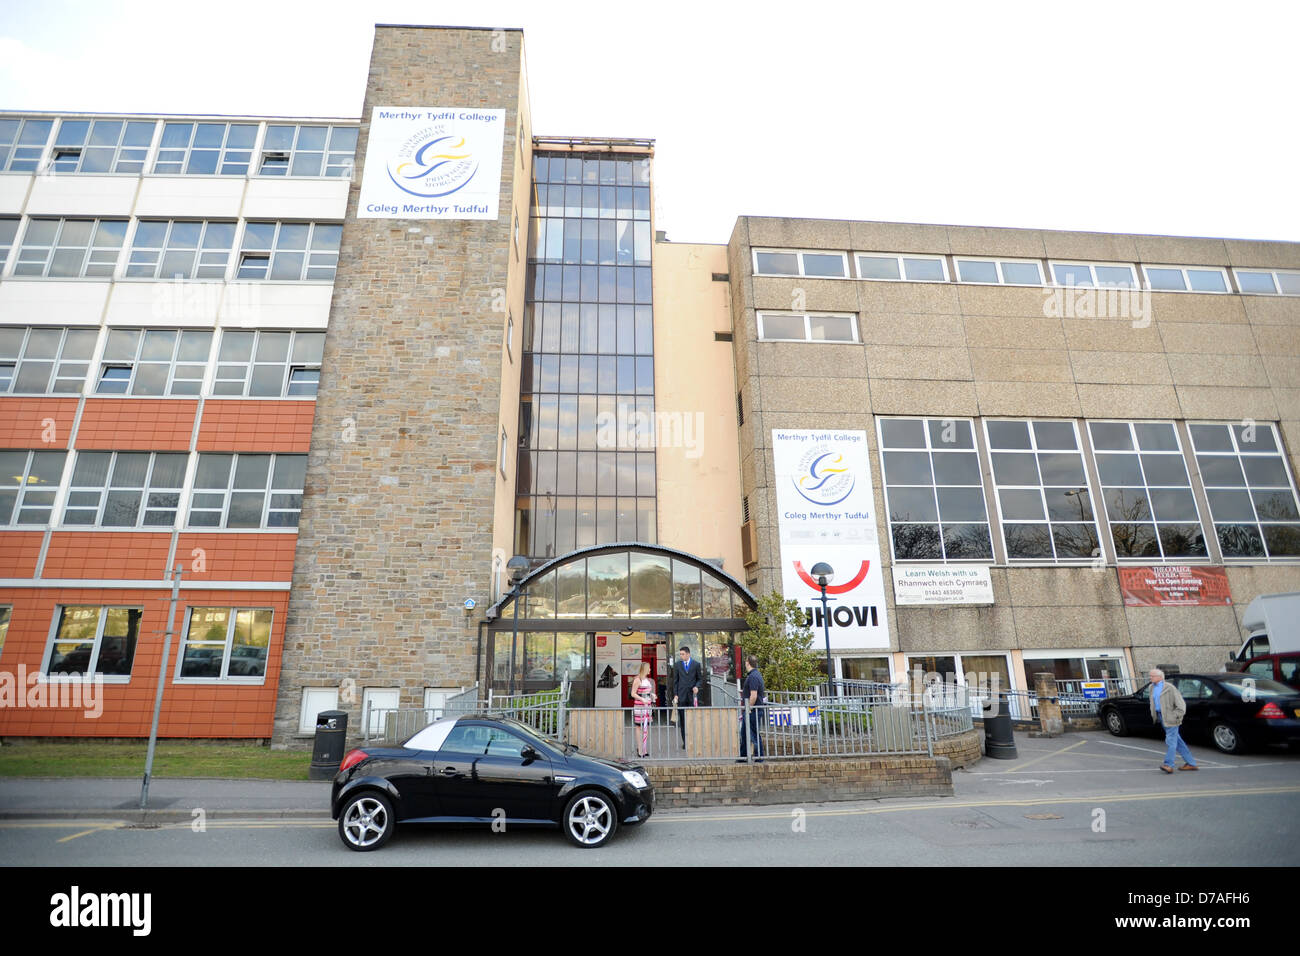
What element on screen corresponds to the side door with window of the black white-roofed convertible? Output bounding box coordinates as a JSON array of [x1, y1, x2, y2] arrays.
[[436, 722, 555, 821]]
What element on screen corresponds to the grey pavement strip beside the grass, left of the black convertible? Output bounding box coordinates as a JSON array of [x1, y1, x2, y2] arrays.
[[0, 777, 330, 823]]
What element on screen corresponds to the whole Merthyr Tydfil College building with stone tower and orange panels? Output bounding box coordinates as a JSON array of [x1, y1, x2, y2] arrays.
[[0, 20, 1300, 747]]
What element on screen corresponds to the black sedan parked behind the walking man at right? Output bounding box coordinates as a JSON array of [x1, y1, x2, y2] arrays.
[[1099, 674, 1300, 753]]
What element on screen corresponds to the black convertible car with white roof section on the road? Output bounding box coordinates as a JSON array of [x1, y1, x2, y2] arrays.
[[330, 717, 654, 851]]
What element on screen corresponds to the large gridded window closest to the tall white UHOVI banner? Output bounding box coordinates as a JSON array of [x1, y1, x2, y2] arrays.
[[879, 419, 993, 562]]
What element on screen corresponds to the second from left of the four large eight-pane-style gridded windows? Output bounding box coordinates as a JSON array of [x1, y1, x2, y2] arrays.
[[984, 420, 1101, 561]]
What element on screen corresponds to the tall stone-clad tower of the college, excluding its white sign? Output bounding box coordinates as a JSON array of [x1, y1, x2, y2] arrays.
[[274, 20, 532, 747]]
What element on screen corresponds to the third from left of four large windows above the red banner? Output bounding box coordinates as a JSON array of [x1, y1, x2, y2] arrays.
[[1088, 421, 1208, 561]]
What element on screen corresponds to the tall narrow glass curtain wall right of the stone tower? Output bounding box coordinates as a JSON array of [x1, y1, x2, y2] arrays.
[[515, 151, 658, 559]]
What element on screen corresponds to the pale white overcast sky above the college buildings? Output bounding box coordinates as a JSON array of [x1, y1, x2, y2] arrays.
[[0, 0, 1300, 242]]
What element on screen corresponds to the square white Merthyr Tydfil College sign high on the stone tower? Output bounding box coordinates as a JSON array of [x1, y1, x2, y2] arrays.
[[356, 107, 506, 219]]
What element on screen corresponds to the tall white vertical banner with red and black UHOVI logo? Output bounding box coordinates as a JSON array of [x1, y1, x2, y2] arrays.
[[772, 428, 889, 649]]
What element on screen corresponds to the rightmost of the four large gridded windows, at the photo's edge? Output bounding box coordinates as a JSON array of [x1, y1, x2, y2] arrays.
[[1188, 424, 1300, 559]]
